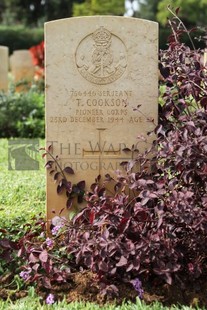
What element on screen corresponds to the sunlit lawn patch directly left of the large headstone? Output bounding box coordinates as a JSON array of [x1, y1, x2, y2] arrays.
[[0, 139, 45, 229]]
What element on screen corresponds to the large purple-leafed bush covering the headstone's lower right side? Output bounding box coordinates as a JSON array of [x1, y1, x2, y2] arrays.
[[54, 10, 207, 290]]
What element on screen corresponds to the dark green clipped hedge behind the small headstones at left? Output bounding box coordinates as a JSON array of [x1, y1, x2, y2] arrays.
[[0, 26, 44, 54]]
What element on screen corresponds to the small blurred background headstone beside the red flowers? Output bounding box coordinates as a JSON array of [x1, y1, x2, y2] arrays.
[[10, 50, 35, 91]]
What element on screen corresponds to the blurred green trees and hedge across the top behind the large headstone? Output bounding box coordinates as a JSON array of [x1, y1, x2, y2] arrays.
[[0, 0, 207, 53]]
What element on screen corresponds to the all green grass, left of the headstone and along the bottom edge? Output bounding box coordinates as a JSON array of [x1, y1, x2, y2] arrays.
[[0, 139, 204, 310]]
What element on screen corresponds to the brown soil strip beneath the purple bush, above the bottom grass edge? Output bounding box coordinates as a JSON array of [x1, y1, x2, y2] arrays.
[[0, 271, 207, 308]]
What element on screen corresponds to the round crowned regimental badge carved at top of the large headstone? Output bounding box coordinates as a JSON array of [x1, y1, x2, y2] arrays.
[[75, 26, 127, 84]]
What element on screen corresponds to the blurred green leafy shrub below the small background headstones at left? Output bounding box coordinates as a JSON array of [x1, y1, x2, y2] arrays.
[[0, 89, 44, 138]]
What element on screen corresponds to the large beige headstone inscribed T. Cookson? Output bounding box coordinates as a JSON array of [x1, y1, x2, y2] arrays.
[[45, 16, 158, 224]]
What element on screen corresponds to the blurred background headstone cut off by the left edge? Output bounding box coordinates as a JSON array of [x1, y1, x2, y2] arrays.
[[0, 46, 9, 92]]
